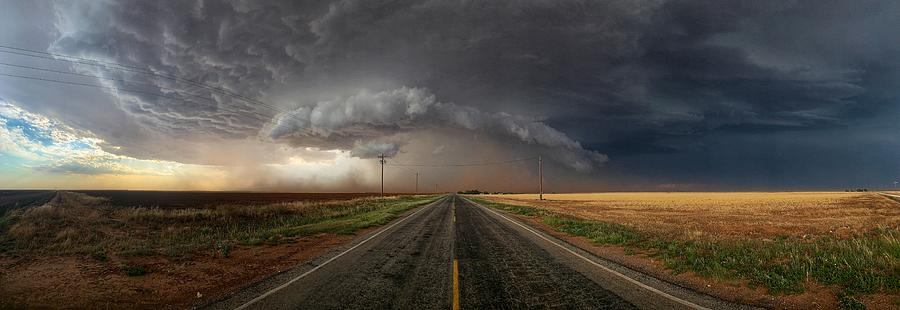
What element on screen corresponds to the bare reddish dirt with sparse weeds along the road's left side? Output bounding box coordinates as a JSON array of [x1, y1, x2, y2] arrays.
[[0, 234, 358, 309]]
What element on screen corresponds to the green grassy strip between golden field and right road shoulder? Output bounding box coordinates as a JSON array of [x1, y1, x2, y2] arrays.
[[472, 198, 900, 308]]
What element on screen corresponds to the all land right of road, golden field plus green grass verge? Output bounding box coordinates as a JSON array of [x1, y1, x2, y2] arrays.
[[472, 192, 900, 309]]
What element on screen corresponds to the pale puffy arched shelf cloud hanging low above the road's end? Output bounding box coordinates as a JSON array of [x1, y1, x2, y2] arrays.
[[269, 87, 607, 171]]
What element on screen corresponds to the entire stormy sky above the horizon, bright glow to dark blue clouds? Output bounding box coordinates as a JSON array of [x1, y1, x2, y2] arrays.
[[0, 0, 900, 192]]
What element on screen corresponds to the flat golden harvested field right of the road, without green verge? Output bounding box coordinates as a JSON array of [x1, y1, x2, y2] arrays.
[[486, 192, 900, 239]]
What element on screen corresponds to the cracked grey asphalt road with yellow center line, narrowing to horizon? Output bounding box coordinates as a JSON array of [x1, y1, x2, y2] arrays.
[[211, 195, 734, 309]]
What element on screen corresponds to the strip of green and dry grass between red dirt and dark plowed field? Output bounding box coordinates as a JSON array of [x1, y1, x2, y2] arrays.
[[0, 192, 439, 261]]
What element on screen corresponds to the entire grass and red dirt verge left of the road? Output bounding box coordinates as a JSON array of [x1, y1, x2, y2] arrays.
[[0, 192, 437, 309]]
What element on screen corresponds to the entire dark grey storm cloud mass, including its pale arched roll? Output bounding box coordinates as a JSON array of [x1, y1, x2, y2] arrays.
[[38, 0, 900, 186]]
